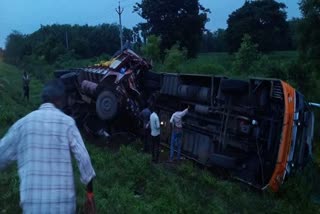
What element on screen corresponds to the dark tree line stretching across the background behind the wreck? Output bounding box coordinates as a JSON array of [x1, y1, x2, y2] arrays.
[[4, 0, 320, 68]]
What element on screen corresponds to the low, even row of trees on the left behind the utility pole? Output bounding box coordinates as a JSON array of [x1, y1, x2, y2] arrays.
[[4, 24, 134, 65]]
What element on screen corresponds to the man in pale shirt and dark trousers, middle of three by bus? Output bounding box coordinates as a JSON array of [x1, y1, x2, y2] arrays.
[[150, 107, 160, 163]]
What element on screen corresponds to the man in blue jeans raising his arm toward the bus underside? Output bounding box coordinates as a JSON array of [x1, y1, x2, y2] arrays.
[[170, 107, 189, 162]]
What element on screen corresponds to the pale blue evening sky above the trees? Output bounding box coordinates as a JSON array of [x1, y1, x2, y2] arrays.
[[0, 0, 301, 48]]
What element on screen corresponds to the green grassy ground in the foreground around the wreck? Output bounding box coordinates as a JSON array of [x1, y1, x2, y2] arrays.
[[0, 53, 320, 213]]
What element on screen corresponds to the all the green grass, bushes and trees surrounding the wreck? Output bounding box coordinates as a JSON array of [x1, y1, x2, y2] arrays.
[[0, 0, 320, 213]]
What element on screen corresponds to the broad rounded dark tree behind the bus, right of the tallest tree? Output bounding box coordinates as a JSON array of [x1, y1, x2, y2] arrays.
[[202, 0, 300, 53]]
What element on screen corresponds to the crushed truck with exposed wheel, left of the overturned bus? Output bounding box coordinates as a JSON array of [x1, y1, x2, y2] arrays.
[[55, 50, 151, 135]]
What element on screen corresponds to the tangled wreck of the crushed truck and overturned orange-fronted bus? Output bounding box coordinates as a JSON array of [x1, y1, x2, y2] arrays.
[[55, 50, 314, 191]]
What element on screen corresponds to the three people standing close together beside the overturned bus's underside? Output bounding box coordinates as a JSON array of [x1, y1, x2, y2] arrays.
[[140, 106, 189, 163]]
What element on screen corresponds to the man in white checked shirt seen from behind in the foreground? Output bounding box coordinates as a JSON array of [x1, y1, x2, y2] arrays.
[[0, 80, 95, 213]]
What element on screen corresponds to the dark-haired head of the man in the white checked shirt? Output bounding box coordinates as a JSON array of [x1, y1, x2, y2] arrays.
[[41, 79, 65, 109]]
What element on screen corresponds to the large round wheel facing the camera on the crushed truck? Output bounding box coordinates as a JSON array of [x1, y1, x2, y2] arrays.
[[96, 91, 118, 120]]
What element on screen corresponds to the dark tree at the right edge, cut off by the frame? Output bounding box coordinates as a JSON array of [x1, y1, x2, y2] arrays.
[[289, 0, 320, 100]]
